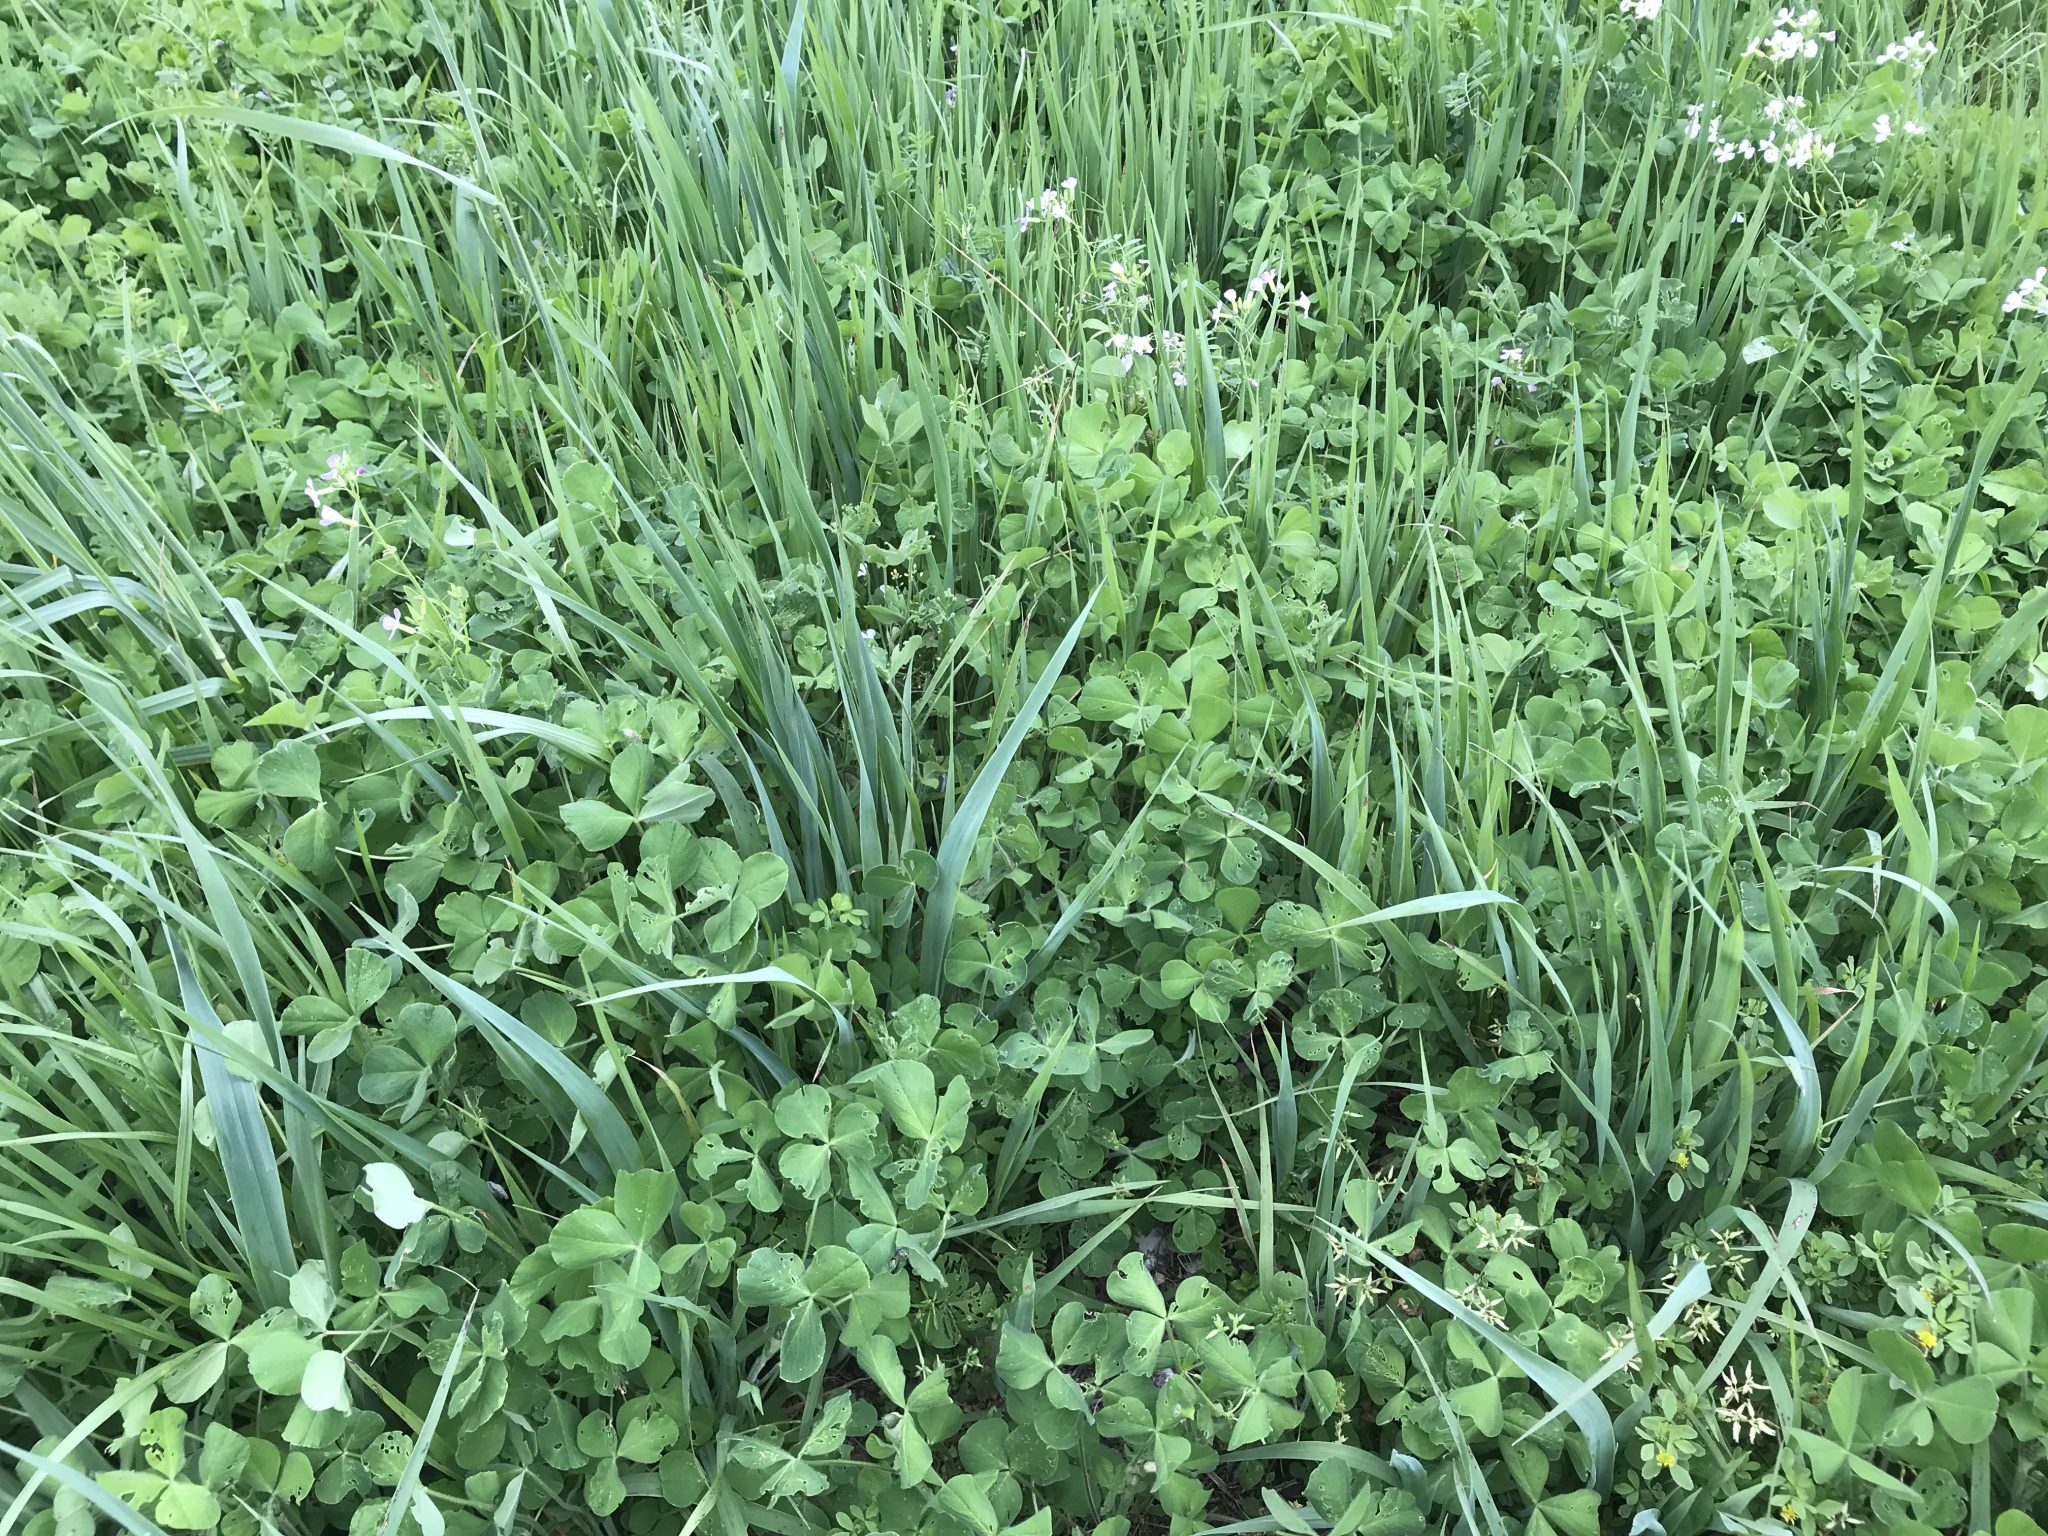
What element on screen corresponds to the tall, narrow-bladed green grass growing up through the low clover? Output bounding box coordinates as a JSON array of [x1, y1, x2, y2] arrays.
[[0, 0, 2048, 1532]]
